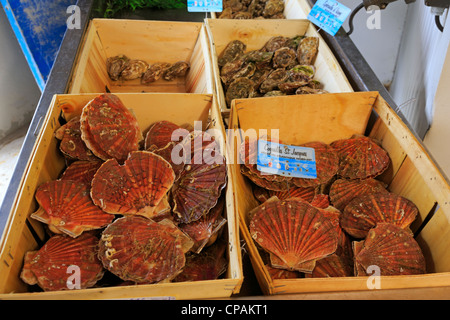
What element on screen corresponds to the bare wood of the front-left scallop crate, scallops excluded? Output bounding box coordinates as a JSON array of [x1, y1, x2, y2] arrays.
[[0, 93, 243, 299]]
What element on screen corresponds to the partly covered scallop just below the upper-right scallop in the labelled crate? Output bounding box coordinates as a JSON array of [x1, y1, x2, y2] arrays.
[[329, 178, 388, 211]]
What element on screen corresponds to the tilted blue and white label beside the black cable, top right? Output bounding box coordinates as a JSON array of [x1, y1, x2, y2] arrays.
[[308, 0, 352, 36]]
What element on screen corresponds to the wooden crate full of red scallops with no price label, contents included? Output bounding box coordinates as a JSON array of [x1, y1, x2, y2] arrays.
[[0, 93, 243, 299]]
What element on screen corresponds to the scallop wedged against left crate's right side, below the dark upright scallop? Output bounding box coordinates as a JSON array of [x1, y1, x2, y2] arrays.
[[178, 197, 227, 253]]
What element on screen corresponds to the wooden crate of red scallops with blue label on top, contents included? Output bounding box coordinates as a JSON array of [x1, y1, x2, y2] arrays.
[[228, 92, 450, 298]]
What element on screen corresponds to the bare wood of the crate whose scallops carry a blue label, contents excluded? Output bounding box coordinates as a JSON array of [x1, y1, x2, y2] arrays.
[[228, 92, 450, 295]]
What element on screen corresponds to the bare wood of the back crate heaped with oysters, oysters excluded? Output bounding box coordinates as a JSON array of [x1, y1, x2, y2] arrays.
[[205, 19, 353, 110]]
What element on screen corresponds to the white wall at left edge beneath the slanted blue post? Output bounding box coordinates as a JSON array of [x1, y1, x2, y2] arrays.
[[0, 5, 41, 142]]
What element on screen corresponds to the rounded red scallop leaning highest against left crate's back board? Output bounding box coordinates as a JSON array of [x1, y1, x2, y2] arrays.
[[80, 93, 143, 162]]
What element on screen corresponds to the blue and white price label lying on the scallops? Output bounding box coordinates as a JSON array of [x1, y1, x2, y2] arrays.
[[256, 140, 317, 179]]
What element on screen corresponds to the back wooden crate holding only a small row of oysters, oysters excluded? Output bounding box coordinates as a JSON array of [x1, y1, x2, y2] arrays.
[[68, 19, 213, 93]]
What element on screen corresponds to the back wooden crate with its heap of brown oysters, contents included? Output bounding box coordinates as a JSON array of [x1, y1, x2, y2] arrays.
[[205, 19, 353, 110]]
